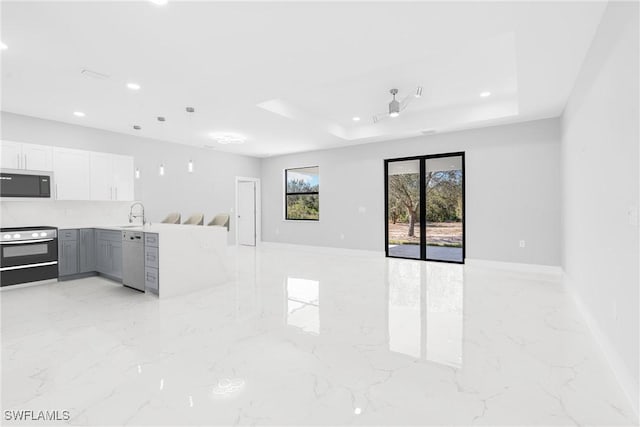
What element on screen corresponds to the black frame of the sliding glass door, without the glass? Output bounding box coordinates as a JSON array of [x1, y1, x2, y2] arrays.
[[384, 151, 467, 264]]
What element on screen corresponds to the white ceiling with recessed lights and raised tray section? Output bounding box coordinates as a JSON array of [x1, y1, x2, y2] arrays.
[[1, 1, 606, 156]]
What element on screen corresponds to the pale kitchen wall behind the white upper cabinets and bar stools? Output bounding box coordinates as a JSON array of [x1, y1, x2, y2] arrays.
[[1, 112, 260, 242]]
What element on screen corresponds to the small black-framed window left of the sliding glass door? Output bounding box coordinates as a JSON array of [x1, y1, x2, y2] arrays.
[[284, 166, 320, 221]]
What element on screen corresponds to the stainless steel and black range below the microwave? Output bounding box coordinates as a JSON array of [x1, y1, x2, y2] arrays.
[[0, 227, 58, 286]]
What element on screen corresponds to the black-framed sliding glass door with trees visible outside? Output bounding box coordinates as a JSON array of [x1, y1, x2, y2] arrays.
[[384, 153, 465, 263]]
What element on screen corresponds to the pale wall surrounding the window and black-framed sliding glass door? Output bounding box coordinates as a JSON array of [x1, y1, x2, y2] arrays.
[[262, 119, 560, 266]]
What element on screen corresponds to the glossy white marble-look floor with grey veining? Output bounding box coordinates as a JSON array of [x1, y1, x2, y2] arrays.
[[1, 247, 637, 425]]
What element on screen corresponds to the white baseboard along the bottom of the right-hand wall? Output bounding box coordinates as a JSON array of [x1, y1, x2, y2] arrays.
[[563, 274, 640, 417]]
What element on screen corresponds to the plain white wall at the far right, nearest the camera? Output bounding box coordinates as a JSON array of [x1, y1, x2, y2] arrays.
[[562, 2, 640, 412]]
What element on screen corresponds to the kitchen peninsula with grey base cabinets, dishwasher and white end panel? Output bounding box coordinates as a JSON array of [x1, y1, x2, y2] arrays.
[[59, 224, 229, 298]]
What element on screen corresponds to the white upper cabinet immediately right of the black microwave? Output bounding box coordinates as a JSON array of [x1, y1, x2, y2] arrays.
[[53, 147, 91, 200]]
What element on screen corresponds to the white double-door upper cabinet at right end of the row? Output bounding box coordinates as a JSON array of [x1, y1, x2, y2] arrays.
[[91, 153, 133, 201]]
